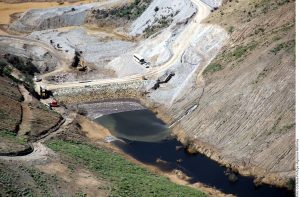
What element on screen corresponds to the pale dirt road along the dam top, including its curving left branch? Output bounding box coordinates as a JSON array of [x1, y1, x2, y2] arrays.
[[0, 0, 210, 90]]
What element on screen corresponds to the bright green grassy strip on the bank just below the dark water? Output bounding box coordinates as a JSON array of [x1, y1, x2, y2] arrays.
[[48, 140, 205, 197]]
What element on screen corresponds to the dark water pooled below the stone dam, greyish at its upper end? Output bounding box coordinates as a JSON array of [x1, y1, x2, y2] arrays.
[[95, 109, 294, 197]]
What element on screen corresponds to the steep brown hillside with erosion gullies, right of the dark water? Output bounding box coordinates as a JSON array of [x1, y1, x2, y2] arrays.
[[169, 0, 295, 189]]
